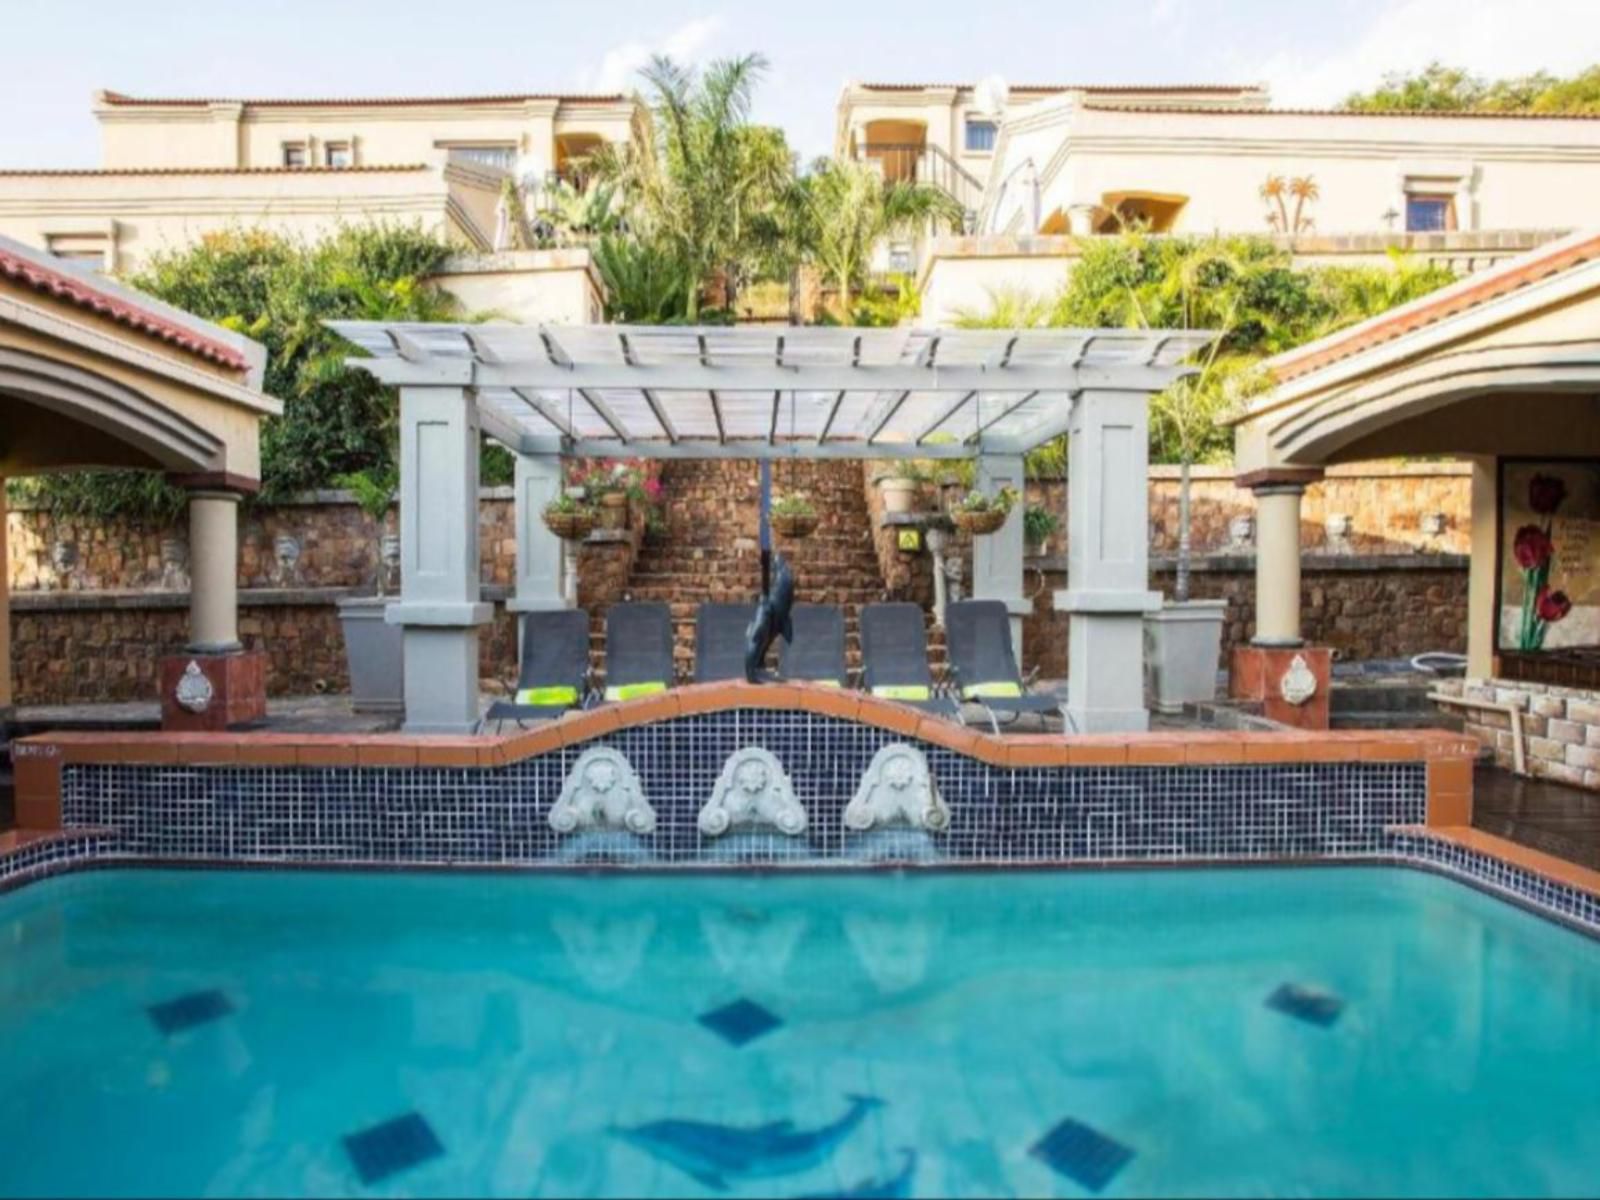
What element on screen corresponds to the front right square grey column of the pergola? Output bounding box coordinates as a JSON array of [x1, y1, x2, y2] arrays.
[[1056, 390, 1162, 733]]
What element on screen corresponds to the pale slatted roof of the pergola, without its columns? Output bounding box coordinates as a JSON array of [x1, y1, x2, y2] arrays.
[[330, 322, 1211, 458]]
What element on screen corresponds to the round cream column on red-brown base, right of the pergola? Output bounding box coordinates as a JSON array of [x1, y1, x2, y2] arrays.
[[1229, 467, 1333, 730]]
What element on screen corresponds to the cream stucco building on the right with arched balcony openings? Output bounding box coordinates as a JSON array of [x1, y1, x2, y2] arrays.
[[835, 82, 1600, 325]]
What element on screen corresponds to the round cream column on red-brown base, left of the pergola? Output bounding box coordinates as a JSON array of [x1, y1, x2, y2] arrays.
[[160, 475, 267, 731]]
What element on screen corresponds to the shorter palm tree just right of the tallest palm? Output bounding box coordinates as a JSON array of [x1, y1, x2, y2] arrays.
[[808, 160, 962, 320]]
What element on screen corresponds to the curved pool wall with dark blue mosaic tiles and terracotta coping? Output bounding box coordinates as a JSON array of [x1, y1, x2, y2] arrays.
[[12, 685, 1600, 931]]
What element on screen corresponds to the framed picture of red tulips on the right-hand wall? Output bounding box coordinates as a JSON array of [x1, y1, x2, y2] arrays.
[[1498, 459, 1600, 653]]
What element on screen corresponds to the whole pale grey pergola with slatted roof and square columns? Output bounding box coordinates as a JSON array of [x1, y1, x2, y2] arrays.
[[331, 322, 1210, 731]]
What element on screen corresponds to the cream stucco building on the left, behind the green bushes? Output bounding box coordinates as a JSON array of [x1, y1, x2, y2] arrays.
[[0, 91, 642, 322]]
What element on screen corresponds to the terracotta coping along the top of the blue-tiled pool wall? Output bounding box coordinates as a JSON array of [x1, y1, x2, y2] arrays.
[[13, 683, 1478, 830]]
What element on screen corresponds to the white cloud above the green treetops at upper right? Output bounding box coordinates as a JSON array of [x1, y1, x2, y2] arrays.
[[1261, 0, 1600, 106]]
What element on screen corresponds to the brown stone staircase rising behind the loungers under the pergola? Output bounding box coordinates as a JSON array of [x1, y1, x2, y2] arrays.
[[590, 459, 944, 682]]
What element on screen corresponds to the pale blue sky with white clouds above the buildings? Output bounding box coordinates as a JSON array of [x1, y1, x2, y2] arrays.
[[0, 0, 1600, 166]]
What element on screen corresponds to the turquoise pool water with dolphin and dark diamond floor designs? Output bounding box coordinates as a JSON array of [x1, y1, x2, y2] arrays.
[[0, 867, 1600, 1197]]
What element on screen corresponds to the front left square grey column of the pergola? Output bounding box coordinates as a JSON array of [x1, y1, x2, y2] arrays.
[[387, 387, 493, 733]]
